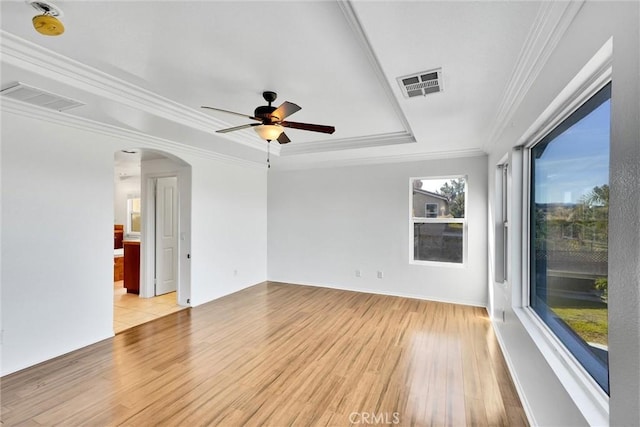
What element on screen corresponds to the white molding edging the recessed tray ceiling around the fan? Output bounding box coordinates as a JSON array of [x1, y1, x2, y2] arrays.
[[0, 28, 415, 156]]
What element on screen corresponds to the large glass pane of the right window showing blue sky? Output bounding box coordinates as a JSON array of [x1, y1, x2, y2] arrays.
[[530, 84, 611, 392]]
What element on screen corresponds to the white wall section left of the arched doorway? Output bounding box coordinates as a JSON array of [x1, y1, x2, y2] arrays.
[[1, 113, 114, 374]]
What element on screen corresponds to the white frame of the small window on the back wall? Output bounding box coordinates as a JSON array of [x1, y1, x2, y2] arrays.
[[409, 175, 469, 268]]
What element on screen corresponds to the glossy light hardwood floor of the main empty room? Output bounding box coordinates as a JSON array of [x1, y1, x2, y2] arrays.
[[1, 283, 527, 426]]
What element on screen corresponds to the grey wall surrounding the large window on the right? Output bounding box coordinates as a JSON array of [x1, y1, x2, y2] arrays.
[[488, 2, 640, 426]]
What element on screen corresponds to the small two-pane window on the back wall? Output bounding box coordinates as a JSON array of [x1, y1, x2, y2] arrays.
[[411, 177, 467, 264]]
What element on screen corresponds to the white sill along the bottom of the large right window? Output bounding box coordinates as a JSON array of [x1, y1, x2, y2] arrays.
[[513, 307, 609, 425]]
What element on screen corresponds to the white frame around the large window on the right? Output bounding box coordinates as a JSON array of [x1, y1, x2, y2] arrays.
[[509, 39, 613, 425]]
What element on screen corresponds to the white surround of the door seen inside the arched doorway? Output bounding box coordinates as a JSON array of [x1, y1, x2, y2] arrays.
[[140, 159, 191, 307]]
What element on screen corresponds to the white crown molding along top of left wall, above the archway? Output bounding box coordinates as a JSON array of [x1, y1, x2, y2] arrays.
[[0, 96, 265, 169]]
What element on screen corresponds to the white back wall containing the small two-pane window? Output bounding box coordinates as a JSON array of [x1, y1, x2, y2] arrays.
[[268, 157, 487, 306]]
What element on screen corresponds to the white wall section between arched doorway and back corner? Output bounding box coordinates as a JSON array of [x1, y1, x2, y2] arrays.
[[175, 156, 267, 306]]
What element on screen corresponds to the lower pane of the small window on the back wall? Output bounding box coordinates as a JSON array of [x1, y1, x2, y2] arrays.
[[413, 222, 464, 263]]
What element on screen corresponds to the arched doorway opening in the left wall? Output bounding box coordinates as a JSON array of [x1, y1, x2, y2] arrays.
[[113, 149, 191, 333]]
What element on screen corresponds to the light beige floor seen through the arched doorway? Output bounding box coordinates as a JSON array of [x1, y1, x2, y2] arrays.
[[113, 280, 186, 334]]
